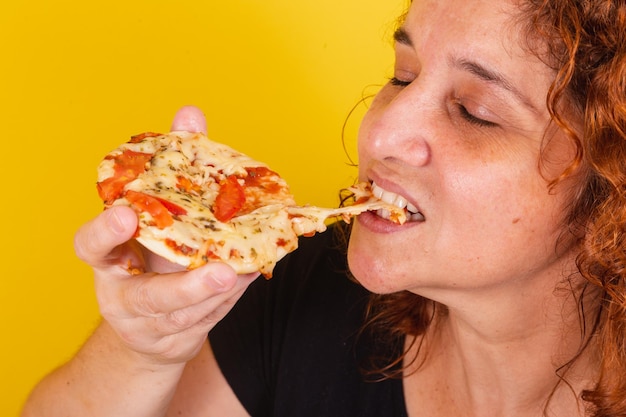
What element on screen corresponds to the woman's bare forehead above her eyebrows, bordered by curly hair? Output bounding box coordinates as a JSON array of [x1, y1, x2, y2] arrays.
[[396, 0, 554, 108]]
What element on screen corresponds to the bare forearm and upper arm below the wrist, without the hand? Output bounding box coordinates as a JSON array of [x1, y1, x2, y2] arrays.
[[22, 322, 248, 417]]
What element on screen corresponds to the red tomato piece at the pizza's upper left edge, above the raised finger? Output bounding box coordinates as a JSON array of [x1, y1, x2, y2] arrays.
[[97, 149, 152, 204]]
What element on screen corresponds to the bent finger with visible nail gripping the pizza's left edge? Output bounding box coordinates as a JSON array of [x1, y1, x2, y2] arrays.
[[74, 206, 137, 267]]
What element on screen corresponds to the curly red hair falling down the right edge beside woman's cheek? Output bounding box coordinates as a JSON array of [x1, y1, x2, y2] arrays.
[[525, 0, 626, 417]]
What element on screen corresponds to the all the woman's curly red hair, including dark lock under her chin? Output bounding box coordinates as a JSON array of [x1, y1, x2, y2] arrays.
[[356, 0, 626, 417]]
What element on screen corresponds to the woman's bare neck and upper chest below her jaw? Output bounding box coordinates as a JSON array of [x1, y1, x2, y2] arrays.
[[405, 272, 594, 417]]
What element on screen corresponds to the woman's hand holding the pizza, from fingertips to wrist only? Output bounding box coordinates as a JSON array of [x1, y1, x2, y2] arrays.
[[75, 108, 258, 363]]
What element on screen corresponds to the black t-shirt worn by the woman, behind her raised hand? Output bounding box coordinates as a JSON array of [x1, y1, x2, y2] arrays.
[[209, 228, 407, 417]]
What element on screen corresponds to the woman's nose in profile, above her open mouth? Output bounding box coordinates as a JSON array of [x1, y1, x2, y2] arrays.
[[359, 83, 434, 166]]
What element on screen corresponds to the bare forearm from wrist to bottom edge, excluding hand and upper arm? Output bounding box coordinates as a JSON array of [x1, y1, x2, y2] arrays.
[[22, 322, 184, 417]]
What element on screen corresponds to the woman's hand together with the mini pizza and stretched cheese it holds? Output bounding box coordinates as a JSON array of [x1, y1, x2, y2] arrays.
[[76, 107, 407, 362]]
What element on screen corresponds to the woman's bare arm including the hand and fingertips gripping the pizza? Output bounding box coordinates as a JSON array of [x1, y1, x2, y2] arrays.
[[22, 108, 255, 417]]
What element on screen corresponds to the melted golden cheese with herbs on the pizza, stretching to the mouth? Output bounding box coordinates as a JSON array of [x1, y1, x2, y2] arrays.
[[98, 132, 406, 277]]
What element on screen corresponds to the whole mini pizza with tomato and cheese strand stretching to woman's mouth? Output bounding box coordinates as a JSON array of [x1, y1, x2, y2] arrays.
[[97, 132, 406, 278]]
